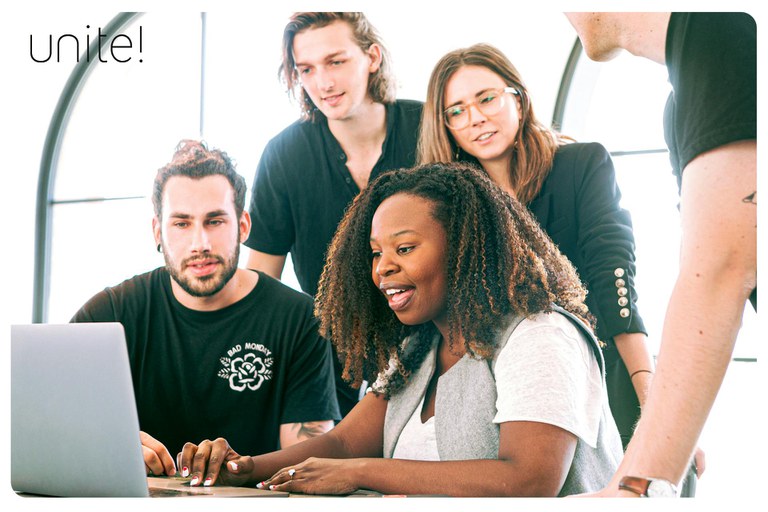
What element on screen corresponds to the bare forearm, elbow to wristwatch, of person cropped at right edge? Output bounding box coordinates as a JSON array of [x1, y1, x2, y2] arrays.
[[613, 266, 748, 488]]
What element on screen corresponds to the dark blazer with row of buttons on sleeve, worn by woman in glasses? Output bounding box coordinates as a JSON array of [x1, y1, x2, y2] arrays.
[[528, 143, 647, 445]]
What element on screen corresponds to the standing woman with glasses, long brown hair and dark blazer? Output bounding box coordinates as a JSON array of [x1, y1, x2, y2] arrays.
[[418, 44, 653, 452]]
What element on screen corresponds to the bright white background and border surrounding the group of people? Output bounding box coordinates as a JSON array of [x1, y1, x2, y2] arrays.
[[0, 1, 766, 506]]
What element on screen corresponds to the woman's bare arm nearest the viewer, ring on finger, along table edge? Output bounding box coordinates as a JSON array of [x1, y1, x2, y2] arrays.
[[265, 421, 577, 496]]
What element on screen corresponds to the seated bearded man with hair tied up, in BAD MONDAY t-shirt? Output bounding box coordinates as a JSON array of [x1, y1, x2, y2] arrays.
[[72, 140, 339, 485]]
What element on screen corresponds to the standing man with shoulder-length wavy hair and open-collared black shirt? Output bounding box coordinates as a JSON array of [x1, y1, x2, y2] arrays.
[[245, 12, 421, 415]]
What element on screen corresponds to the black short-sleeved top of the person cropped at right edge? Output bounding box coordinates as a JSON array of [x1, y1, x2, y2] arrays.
[[664, 12, 757, 189]]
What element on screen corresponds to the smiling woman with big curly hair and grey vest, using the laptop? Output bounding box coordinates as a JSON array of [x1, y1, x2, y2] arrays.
[[180, 164, 622, 496]]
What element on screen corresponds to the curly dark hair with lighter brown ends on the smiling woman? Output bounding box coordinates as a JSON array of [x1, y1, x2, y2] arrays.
[[315, 163, 594, 396]]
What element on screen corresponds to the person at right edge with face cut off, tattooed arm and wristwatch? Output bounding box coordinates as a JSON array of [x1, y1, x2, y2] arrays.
[[566, 12, 757, 496]]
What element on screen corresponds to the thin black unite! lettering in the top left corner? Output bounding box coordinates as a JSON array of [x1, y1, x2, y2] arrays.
[[29, 25, 144, 64]]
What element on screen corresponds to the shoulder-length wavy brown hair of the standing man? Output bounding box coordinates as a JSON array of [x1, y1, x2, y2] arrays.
[[278, 12, 395, 120]]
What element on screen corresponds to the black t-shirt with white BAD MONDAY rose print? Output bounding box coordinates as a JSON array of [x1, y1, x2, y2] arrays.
[[72, 267, 339, 456]]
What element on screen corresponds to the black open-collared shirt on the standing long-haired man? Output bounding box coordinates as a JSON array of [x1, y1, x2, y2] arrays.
[[245, 100, 422, 295]]
